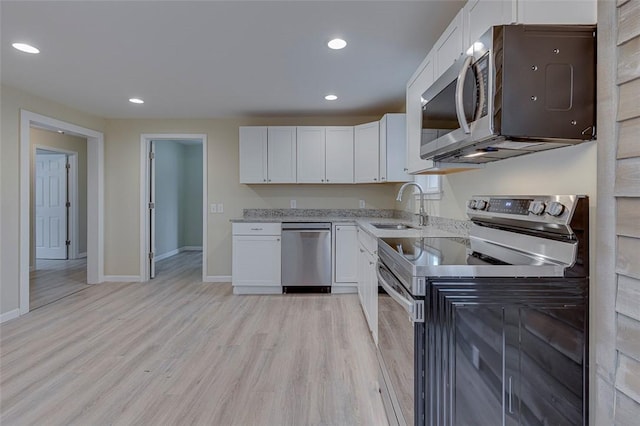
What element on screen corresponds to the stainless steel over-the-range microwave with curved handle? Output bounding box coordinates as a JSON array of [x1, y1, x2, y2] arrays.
[[420, 25, 596, 163]]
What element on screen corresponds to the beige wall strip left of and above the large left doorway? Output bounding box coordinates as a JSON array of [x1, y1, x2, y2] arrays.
[[0, 86, 104, 314]]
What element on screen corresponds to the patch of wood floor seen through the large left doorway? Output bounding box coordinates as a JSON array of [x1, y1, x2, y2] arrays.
[[29, 258, 90, 310]]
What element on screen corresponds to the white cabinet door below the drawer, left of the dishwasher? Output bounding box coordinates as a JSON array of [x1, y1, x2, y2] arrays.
[[232, 235, 282, 286]]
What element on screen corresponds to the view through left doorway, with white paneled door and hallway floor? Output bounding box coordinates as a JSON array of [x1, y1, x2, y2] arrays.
[[29, 131, 89, 310]]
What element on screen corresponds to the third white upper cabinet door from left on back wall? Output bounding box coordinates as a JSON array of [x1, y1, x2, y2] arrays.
[[296, 126, 325, 183]]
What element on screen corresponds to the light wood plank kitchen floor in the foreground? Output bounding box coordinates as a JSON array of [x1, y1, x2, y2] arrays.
[[0, 253, 386, 425]]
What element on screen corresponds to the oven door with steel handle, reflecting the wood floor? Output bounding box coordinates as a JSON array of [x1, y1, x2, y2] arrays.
[[376, 262, 425, 425]]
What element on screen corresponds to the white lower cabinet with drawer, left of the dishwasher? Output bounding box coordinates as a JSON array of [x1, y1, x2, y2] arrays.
[[231, 223, 282, 294]]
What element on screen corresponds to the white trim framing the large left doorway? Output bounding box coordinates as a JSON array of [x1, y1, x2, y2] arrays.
[[18, 110, 104, 315]]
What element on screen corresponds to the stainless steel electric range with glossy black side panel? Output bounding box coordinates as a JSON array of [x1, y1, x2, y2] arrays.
[[378, 195, 589, 426]]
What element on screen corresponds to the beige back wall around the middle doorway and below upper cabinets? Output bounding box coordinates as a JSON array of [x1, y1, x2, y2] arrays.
[[105, 117, 396, 276]]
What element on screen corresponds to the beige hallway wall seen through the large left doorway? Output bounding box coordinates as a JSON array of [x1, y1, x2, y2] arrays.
[[29, 128, 87, 267]]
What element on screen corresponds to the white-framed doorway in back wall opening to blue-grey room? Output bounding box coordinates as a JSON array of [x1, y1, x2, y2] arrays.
[[140, 134, 207, 281]]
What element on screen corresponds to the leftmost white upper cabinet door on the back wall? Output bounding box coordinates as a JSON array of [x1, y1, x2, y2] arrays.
[[239, 127, 267, 183]]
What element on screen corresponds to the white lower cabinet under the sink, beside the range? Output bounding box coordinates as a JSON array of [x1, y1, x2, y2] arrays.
[[358, 229, 378, 345]]
